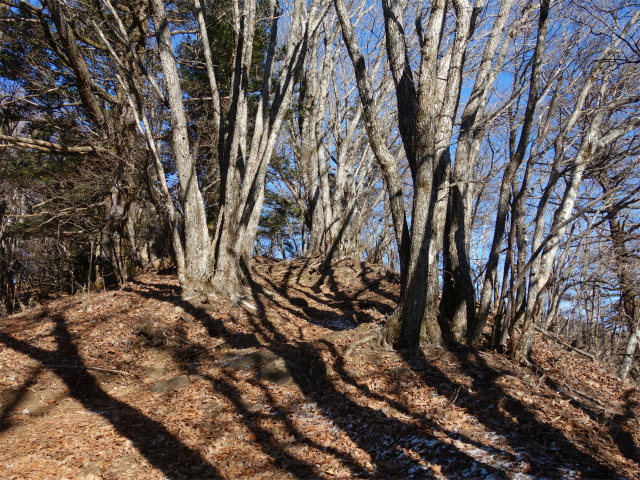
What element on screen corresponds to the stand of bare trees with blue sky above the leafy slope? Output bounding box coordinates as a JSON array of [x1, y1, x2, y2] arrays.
[[0, 0, 640, 377]]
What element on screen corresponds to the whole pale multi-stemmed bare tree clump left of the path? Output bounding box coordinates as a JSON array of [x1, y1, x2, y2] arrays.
[[85, 0, 324, 298]]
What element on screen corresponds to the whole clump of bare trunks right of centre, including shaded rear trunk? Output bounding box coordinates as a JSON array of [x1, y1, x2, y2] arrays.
[[335, 1, 524, 347]]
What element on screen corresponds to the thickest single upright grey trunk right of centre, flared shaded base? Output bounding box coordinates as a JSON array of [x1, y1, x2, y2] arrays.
[[387, 1, 472, 348]]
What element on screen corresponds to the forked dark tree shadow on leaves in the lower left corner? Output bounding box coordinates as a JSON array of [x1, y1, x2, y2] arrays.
[[0, 314, 220, 478]]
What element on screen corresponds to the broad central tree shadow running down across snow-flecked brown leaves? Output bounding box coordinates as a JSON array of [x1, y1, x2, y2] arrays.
[[241, 290, 516, 478]]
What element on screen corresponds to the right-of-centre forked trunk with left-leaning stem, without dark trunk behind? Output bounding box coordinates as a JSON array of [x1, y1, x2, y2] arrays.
[[334, 0, 472, 348]]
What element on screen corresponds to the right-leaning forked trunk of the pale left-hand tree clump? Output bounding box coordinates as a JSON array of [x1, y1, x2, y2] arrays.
[[212, 1, 326, 298]]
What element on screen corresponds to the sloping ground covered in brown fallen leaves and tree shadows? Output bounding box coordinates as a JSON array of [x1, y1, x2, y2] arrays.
[[0, 258, 640, 480]]
